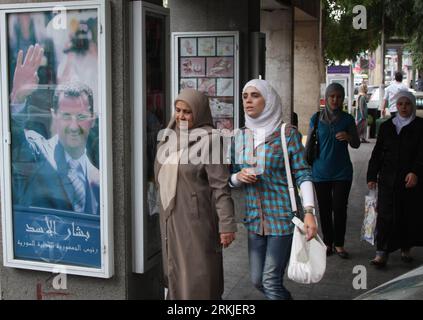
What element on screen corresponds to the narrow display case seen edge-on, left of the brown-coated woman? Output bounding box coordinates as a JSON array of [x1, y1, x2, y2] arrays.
[[130, 1, 170, 273]]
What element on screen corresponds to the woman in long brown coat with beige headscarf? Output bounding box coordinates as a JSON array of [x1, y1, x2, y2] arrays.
[[155, 89, 236, 300]]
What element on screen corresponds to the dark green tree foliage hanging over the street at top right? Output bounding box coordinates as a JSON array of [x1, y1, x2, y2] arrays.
[[322, 0, 423, 69]]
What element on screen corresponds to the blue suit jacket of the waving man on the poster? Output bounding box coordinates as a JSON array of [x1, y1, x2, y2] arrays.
[[12, 130, 100, 214]]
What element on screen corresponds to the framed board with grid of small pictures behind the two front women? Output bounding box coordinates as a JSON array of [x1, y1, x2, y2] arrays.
[[172, 31, 239, 130]]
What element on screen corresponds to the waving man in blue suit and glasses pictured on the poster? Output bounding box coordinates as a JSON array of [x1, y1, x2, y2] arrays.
[[10, 45, 100, 215]]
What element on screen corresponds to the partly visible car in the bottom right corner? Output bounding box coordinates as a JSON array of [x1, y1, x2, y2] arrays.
[[354, 266, 423, 300]]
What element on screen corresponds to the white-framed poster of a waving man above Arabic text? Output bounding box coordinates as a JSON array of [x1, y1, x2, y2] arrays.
[[0, 0, 114, 278]]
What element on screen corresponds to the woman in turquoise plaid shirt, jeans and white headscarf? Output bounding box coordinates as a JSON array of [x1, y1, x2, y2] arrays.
[[231, 79, 317, 300]]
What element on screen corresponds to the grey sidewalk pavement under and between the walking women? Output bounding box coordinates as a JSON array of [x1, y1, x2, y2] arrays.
[[223, 140, 423, 300]]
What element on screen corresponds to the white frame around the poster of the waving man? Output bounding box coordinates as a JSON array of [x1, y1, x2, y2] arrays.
[[0, 0, 114, 278]]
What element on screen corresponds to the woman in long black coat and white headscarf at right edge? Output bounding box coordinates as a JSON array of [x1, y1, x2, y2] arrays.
[[367, 91, 423, 268]]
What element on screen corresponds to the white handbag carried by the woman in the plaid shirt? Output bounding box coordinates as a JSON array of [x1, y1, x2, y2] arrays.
[[288, 217, 326, 284]]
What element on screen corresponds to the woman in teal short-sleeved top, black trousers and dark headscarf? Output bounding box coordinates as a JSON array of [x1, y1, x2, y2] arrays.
[[307, 83, 360, 259]]
